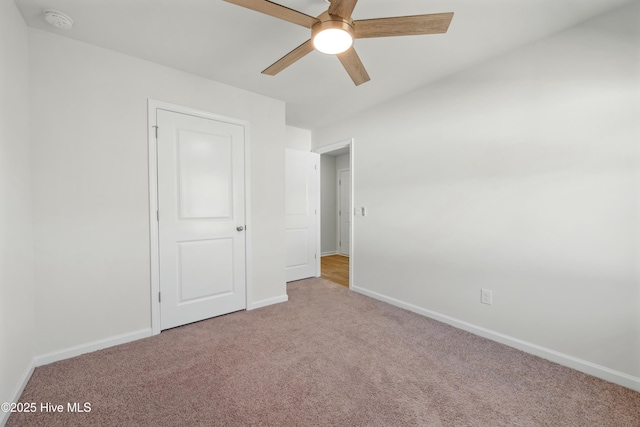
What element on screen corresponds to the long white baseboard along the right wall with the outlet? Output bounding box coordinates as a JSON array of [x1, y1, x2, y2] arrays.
[[351, 286, 640, 392]]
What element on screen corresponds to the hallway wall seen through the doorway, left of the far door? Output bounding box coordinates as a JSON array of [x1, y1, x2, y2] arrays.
[[320, 154, 338, 255]]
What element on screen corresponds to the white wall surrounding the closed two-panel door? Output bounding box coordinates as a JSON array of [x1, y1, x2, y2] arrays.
[[29, 29, 286, 355]]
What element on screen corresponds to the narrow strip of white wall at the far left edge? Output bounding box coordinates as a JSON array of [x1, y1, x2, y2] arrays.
[[0, 1, 35, 416]]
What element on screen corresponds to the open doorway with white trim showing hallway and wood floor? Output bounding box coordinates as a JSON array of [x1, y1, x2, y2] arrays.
[[314, 139, 354, 288]]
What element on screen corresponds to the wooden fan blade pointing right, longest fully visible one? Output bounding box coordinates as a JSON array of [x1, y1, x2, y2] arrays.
[[353, 12, 453, 39]]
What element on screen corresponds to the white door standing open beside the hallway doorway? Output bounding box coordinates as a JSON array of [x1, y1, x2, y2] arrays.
[[285, 149, 320, 282]]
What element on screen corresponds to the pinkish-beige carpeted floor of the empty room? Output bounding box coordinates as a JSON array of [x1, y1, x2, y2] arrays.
[[7, 279, 640, 427]]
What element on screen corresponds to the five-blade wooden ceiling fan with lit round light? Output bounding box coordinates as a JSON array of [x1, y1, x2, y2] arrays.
[[225, 0, 453, 86]]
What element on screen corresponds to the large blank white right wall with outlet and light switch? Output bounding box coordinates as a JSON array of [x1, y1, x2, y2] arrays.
[[314, 2, 640, 389]]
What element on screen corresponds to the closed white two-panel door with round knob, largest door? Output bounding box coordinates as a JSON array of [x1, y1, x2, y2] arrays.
[[157, 109, 246, 329]]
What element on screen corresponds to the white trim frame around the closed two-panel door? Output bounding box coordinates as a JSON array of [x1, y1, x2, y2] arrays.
[[147, 99, 253, 335]]
